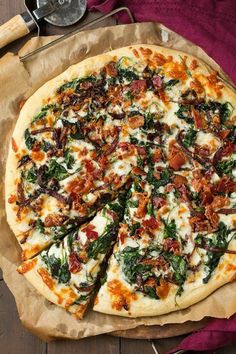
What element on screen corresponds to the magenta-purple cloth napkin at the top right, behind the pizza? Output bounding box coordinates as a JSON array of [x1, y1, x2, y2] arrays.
[[88, 0, 236, 84]]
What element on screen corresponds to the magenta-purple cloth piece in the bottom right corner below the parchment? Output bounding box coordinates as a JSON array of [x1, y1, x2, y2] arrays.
[[167, 314, 236, 354]]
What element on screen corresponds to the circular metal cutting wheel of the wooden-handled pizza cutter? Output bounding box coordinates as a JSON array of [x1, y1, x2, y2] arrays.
[[33, 0, 87, 27]]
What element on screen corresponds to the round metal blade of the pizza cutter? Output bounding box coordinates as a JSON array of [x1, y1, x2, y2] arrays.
[[37, 0, 87, 27]]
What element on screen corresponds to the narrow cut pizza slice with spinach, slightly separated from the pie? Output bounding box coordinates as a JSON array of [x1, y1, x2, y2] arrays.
[[18, 198, 123, 319]]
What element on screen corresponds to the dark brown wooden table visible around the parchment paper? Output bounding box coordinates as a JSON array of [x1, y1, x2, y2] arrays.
[[0, 0, 236, 354]]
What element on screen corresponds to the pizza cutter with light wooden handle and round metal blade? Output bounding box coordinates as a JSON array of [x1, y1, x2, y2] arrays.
[[0, 0, 87, 48]]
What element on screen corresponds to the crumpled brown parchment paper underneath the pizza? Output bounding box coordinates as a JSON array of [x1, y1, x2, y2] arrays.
[[0, 23, 236, 340]]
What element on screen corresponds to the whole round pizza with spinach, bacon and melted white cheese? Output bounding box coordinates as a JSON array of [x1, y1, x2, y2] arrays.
[[6, 45, 236, 319]]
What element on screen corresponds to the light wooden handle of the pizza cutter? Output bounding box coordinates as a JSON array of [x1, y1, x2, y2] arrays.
[[0, 15, 30, 48]]
